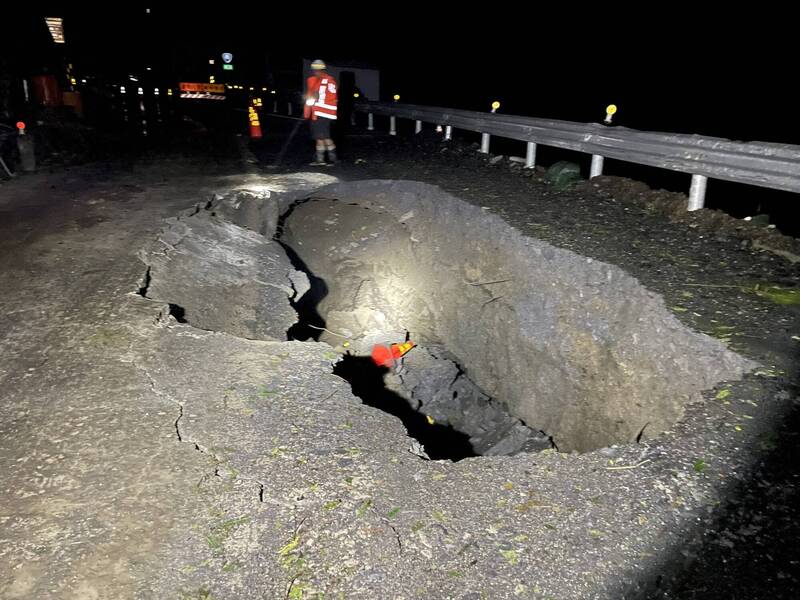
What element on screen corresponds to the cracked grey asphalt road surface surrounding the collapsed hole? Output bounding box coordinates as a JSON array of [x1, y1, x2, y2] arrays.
[[0, 123, 800, 600]]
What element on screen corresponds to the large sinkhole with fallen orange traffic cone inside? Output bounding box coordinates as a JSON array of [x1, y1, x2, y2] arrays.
[[275, 181, 752, 460]]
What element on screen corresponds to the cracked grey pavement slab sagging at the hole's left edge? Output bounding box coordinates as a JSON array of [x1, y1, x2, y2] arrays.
[[141, 211, 309, 340]]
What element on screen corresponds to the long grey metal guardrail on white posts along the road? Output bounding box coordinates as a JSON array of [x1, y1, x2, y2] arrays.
[[354, 102, 800, 210]]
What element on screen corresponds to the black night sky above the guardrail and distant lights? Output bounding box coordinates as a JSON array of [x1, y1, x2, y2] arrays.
[[4, 3, 800, 143]]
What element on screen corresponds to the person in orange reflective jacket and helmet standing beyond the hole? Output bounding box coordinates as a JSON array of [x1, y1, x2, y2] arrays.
[[303, 60, 338, 165]]
